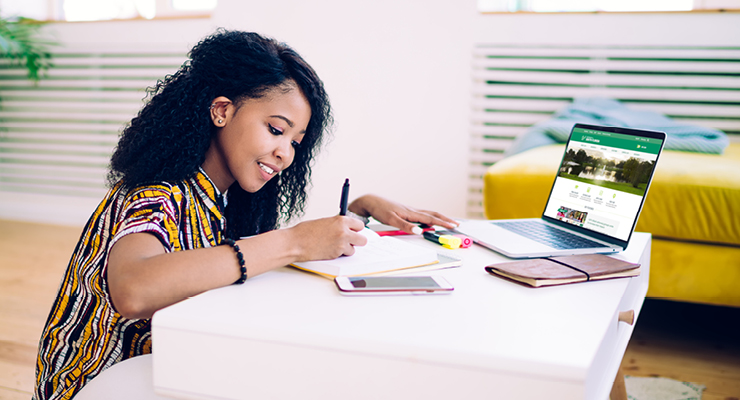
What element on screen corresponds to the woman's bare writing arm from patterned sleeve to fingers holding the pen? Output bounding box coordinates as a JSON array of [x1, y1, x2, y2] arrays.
[[107, 216, 367, 319]]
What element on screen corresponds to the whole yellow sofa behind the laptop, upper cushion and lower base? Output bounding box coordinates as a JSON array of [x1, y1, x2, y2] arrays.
[[483, 143, 740, 307]]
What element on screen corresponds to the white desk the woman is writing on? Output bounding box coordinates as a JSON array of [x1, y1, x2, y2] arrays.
[[152, 233, 651, 400]]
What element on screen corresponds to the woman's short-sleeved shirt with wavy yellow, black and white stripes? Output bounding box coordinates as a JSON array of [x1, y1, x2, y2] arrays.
[[33, 170, 226, 400]]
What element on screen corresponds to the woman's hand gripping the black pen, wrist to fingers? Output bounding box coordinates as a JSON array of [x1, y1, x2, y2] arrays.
[[288, 215, 367, 262]]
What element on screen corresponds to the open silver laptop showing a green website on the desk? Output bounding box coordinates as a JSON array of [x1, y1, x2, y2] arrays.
[[456, 124, 665, 258]]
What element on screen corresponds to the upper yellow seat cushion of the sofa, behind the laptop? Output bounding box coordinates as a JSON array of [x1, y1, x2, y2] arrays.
[[483, 143, 740, 245]]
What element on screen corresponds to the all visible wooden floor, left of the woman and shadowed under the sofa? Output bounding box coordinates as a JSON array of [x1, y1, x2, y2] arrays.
[[0, 220, 740, 400]]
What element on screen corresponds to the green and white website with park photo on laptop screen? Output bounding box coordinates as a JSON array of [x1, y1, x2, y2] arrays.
[[545, 127, 663, 241]]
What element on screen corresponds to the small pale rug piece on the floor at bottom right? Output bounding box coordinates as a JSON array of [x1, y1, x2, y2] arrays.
[[624, 375, 707, 400]]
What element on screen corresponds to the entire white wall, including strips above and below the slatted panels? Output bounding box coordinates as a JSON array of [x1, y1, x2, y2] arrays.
[[0, 4, 740, 225]]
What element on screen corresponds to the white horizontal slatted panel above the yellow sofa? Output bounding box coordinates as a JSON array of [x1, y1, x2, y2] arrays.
[[467, 44, 740, 218]]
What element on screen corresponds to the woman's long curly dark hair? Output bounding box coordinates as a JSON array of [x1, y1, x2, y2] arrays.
[[108, 29, 332, 238]]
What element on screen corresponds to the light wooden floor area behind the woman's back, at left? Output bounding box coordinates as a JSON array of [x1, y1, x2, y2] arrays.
[[0, 220, 82, 400]]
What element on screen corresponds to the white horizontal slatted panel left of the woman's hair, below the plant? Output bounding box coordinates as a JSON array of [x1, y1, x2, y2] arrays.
[[0, 48, 186, 198]]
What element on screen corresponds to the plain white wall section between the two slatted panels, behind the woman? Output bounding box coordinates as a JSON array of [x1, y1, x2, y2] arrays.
[[213, 0, 475, 223]]
